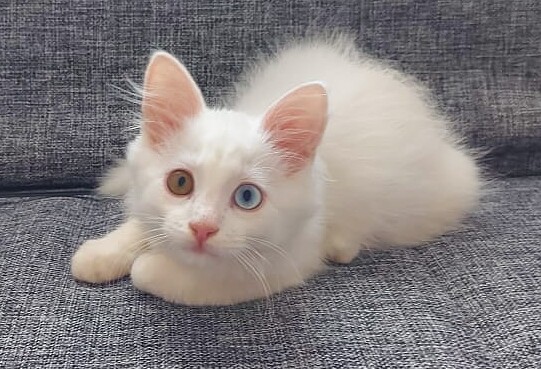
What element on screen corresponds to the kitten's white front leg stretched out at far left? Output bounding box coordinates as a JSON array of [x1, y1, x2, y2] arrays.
[[71, 219, 143, 283]]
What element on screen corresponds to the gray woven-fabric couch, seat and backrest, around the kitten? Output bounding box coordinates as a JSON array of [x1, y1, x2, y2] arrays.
[[0, 0, 541, 368]]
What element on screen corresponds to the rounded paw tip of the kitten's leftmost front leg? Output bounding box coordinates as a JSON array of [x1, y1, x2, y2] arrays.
[[71, 238, 132, 283]]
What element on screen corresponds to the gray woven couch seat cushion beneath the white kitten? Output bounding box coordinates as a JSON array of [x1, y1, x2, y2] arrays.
[[0, 178, 541, 369]]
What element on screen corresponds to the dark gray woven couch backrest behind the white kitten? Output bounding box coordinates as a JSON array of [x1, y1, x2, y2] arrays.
[[0, 0, 541, 188]]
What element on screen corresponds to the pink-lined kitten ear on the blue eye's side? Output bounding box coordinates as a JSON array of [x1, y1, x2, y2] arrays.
[[263, 82, 327, 174]]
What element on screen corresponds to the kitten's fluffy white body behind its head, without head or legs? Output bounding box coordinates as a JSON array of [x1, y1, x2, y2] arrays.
[[233, 39, 480, 249]]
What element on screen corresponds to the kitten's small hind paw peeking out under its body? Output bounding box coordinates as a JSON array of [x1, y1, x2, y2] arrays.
[[324, 226, 361, 264]]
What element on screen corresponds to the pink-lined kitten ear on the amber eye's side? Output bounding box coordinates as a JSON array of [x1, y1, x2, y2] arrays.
[[141, 51, 205, 146]]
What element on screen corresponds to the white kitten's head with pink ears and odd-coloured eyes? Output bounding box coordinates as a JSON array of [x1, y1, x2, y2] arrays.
[[127, 52, 327, 261]]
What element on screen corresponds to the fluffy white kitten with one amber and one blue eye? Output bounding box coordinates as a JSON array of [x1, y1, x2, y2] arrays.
[[72, 37, 480, 305]]
